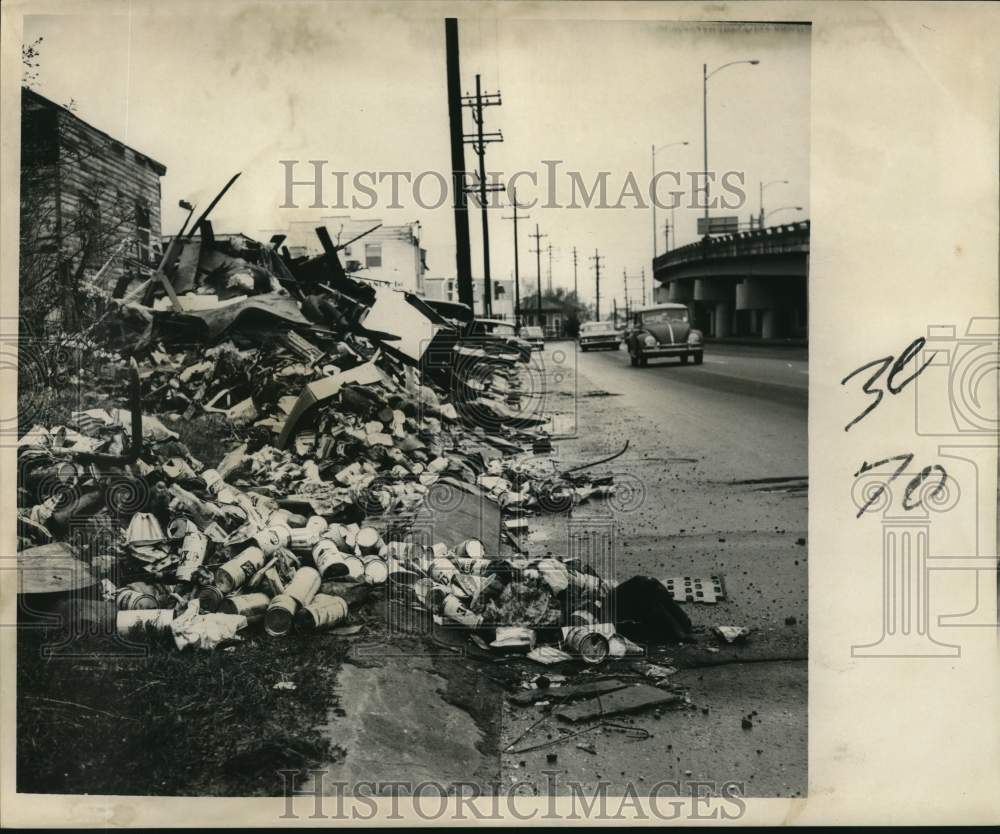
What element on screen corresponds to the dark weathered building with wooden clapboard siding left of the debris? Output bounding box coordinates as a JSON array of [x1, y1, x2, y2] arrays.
[[20, 88, 167, 325]]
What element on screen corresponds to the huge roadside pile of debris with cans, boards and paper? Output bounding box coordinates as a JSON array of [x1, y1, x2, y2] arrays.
[[18, 172, 690, 663]]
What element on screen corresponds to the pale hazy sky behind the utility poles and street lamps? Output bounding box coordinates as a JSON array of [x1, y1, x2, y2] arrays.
[[24, 0, 810, 304]]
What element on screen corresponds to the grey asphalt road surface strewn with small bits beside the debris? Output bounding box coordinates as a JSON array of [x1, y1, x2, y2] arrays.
[[502, 342, 808, 796]]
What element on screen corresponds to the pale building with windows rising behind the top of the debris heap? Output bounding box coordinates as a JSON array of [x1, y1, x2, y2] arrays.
[[266, 215, 427, 295]]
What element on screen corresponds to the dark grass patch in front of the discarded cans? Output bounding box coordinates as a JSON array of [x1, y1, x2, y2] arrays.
[[17, 616, 349, 796]]
